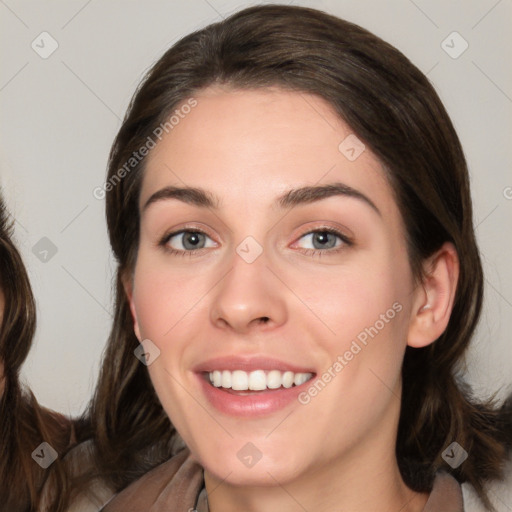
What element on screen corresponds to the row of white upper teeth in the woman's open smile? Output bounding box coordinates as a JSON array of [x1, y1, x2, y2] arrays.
[[209, 370, 313, 391]]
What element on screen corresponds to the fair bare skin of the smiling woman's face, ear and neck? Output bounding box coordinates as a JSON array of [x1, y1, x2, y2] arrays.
[[125, 87, 458, 512]]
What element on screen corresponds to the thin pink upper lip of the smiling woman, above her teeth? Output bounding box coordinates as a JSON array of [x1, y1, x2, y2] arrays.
[[193, 355, 315, 373]]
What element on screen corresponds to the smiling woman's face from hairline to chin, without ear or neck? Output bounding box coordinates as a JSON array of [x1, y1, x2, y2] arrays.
[[127, 88, 424, 485]]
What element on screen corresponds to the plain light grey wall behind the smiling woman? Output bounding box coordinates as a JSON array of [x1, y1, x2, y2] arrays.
[[0, 0, 512, 414]]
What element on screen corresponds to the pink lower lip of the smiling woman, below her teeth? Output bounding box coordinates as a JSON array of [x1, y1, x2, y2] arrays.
[[196, 374, 314, 417]]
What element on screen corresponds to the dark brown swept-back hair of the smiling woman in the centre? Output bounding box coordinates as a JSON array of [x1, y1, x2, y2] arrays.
[[76, 5, 511, 506]]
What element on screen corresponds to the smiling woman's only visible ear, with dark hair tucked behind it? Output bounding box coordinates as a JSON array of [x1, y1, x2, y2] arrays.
[[407, 242, 459, 348]]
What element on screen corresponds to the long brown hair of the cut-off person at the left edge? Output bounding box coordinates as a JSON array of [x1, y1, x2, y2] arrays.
[[0, 197, 75, 512]]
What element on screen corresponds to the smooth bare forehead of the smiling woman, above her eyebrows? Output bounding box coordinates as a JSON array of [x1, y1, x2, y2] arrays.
[[140, 86, 396, 218]]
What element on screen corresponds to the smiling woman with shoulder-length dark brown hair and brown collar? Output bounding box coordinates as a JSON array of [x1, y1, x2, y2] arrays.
[[49, 6, 511, 512]]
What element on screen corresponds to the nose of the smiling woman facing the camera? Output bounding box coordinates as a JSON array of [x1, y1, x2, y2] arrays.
[[210, 245, 287, 334]]
